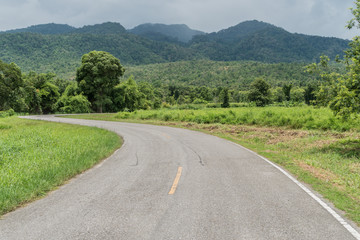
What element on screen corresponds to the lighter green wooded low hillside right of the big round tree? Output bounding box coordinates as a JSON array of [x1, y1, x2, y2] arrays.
[[125, 60, 343, 90]]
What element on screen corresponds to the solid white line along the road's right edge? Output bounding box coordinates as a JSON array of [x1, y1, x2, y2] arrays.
[[230, 141, 360, 240]]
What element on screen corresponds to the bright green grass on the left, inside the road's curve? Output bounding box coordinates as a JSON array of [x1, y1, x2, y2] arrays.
[[0, 117, 122, 215]]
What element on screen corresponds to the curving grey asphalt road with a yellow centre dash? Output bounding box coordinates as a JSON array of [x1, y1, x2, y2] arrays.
[[0, 116, 360, 240]]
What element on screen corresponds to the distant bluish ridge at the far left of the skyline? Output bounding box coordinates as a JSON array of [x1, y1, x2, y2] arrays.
[[2, 23, 76, 34]]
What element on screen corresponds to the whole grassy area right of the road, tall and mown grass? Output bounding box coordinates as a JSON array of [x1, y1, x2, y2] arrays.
[[66, 107, 360, 225]]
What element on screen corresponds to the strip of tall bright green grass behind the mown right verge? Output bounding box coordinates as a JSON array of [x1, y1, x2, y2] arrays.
[[115, 106, 360, 131]]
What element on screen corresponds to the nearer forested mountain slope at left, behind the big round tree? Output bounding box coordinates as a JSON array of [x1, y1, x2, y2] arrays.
[[0, 33, 198, 78]]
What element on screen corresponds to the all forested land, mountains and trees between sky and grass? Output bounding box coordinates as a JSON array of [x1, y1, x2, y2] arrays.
[[0, 15, 358, 117]]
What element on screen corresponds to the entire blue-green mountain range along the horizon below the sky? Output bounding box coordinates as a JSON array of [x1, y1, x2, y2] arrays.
[[0, 20, 349, 78]]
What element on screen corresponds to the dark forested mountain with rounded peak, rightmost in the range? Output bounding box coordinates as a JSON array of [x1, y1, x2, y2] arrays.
[[190, 20, 349, 62]]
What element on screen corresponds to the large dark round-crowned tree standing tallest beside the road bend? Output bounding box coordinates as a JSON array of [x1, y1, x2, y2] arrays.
[[76, 51, 125, 113]]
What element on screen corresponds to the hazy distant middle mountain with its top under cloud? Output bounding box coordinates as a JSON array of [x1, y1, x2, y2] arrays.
[[129, 23, 205, 43]]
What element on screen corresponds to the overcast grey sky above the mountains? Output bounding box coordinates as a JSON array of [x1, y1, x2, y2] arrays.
[[0, 0, 360, 39]]
